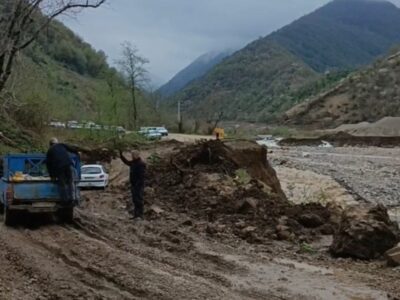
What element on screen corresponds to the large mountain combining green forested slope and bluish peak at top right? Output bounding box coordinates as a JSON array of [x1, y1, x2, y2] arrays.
[[170, 0, 400, 121]]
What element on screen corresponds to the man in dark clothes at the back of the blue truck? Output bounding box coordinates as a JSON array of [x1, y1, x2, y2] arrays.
[[46, 138, 78, 202]]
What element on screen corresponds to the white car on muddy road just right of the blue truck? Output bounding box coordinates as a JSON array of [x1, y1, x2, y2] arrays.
[[79, 165, 109, 189]]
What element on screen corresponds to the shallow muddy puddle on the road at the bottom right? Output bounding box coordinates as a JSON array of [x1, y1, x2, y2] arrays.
[[216, 255, 388, 300]]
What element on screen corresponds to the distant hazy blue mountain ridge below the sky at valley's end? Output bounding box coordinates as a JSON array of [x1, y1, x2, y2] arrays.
[[158, 50, 233, 97]]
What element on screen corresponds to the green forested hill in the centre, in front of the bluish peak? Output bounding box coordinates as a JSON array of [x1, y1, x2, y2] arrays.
[[178, 40, 318, 120]]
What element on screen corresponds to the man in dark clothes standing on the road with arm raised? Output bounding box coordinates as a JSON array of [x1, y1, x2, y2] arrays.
[[120, 151, 146, 219]]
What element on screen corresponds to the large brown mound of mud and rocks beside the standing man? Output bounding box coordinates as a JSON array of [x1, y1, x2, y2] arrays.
[[145, 141, 332, 243]]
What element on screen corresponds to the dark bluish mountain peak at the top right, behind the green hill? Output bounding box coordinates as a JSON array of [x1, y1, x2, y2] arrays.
[[268, 0, 400, 72]]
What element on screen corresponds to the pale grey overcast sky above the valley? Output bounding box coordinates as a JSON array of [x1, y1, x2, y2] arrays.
[[63, 0, 400, 85]]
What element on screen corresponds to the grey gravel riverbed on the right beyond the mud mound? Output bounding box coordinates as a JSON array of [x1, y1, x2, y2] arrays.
[[269, 147, 400, 208]]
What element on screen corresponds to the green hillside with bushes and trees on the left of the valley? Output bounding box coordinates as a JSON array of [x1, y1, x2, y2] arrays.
[[3, 21, 158, 131]]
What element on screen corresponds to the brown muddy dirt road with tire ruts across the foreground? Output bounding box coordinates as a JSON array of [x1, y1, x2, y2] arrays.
[[0, 192, 386, 299]]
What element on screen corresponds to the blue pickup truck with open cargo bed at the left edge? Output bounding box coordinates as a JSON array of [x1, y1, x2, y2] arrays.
[[0, 154, 81, 226]]
